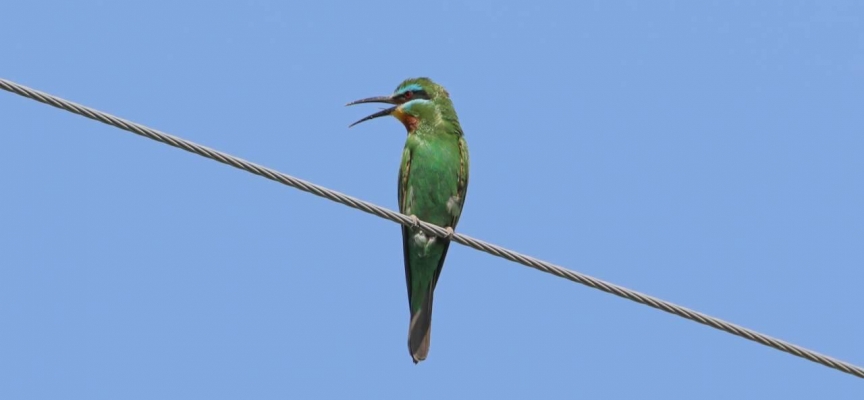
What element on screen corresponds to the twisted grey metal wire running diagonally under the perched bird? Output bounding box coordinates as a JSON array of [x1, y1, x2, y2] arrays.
[[0, 78, 864, 378]]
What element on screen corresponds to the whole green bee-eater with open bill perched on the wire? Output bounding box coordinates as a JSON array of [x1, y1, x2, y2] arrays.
[[347, 77, 469, 364]]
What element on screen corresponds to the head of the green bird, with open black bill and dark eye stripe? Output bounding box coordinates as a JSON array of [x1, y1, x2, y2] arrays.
[[346, 78, 453, 132]]
